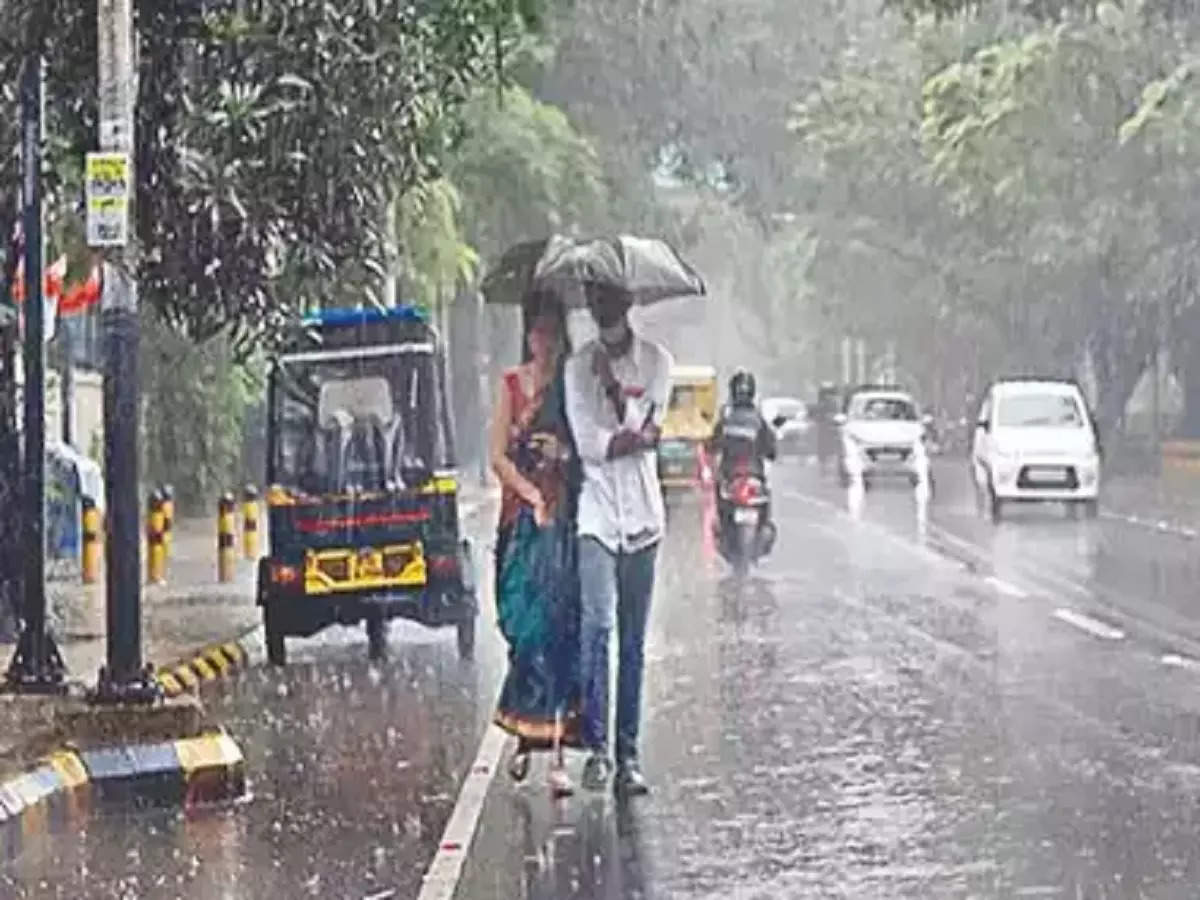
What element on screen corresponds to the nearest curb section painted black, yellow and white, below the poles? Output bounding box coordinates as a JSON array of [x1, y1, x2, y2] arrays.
[[0, 731, 246, 862]]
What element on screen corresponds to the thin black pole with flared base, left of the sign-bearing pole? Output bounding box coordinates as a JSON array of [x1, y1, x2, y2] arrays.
[[7, 52, 66, 694]]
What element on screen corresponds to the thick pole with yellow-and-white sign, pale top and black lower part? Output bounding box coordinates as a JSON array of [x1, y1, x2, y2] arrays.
[[88, 0, 158, 702]]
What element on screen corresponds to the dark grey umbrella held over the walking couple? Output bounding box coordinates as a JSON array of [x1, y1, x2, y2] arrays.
[[482, 234, 706, 307]]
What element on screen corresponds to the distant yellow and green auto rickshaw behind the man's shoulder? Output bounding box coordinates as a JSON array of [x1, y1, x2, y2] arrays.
[[659, 366, 718, 491]]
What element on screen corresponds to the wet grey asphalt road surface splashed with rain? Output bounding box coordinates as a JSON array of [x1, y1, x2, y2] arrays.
[[11, 463, 1200, 900]]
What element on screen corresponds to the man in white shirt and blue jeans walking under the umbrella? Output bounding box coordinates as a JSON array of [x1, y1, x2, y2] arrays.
[[565, 286, 671, 794]]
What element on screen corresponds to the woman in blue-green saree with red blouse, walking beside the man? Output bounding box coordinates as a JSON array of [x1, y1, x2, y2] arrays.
[[491, 295, 580, 797]]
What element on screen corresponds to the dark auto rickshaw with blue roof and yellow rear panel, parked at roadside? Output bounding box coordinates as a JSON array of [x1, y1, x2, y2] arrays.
[[257, 307, 478, 665]]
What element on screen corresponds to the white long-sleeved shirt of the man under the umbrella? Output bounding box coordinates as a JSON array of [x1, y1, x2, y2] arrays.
[[565, 336, 671, 553]]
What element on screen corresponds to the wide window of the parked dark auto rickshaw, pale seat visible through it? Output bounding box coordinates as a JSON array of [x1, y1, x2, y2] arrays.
[[271, 344, 452, 494]]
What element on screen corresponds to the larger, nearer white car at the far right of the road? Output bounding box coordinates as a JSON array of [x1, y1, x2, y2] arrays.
[[971, 379, 1100, 521]]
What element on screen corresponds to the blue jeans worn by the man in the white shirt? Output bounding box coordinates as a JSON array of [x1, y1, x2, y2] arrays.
[[580, 538, 658, 763]]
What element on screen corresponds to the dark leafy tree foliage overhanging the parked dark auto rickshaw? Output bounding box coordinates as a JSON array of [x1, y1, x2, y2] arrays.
[[0, 0, 541, 359]]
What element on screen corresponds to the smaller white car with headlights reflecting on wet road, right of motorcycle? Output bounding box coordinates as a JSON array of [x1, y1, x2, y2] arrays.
[[836, 389, 931, 487]]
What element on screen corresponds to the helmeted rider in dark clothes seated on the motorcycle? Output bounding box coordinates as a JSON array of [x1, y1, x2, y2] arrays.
[[712, 368, 776, 552]]
